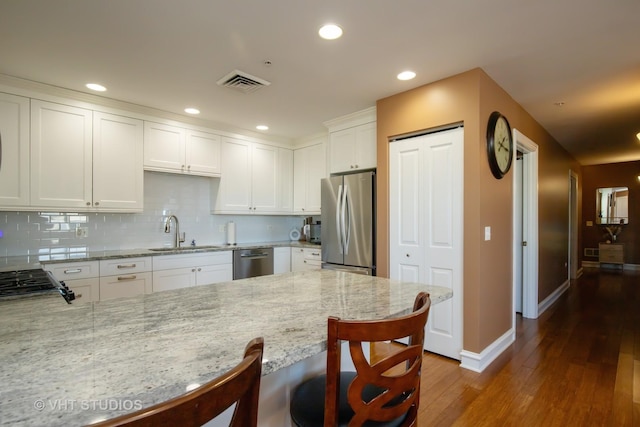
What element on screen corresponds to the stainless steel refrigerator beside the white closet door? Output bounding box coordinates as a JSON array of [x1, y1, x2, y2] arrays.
[[321, 171, 376, 276]]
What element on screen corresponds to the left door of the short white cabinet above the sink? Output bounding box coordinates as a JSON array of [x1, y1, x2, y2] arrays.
[[144, 122, 186, 173]]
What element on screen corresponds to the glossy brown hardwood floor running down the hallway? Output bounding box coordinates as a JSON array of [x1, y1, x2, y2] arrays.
[[419, 269, 640, 427]]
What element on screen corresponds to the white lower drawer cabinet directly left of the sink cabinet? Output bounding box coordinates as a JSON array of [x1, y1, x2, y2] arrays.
[[100, 257, 153, 301]]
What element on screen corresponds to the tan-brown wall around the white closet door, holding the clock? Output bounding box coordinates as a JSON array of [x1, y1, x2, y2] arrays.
[[377, 69, 580, 352]]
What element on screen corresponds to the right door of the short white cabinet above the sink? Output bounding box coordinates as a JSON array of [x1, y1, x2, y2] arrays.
[[185, 130, 220, 177]]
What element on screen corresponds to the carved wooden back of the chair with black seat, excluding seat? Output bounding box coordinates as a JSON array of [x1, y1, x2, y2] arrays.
[[324, 292, 431, 427]]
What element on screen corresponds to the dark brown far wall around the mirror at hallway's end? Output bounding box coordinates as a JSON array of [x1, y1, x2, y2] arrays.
[[580, 161, 640, 264]]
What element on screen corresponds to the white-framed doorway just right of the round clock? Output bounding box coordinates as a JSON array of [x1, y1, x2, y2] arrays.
[[512, 129, 538, 320]]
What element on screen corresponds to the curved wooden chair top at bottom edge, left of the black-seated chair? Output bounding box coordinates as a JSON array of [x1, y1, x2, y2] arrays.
[[91, 338, 264, 427]]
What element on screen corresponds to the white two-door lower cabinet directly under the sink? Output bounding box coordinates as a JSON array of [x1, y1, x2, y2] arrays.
[[153, 251, 233, 292]]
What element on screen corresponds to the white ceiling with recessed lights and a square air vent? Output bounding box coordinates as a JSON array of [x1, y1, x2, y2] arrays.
[[0, 0, 640, 165]]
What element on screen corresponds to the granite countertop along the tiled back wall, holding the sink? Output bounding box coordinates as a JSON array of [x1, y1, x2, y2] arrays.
[[0, 240, 321, 271]]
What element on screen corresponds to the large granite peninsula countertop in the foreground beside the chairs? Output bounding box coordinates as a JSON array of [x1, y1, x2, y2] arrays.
[[0, 270, 452, 426]]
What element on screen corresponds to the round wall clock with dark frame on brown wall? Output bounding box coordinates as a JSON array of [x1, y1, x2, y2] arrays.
[[487, 111, 513, 179]]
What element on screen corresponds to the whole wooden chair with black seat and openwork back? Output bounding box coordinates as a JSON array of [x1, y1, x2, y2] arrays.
[[291, 292, 431, 427]]
